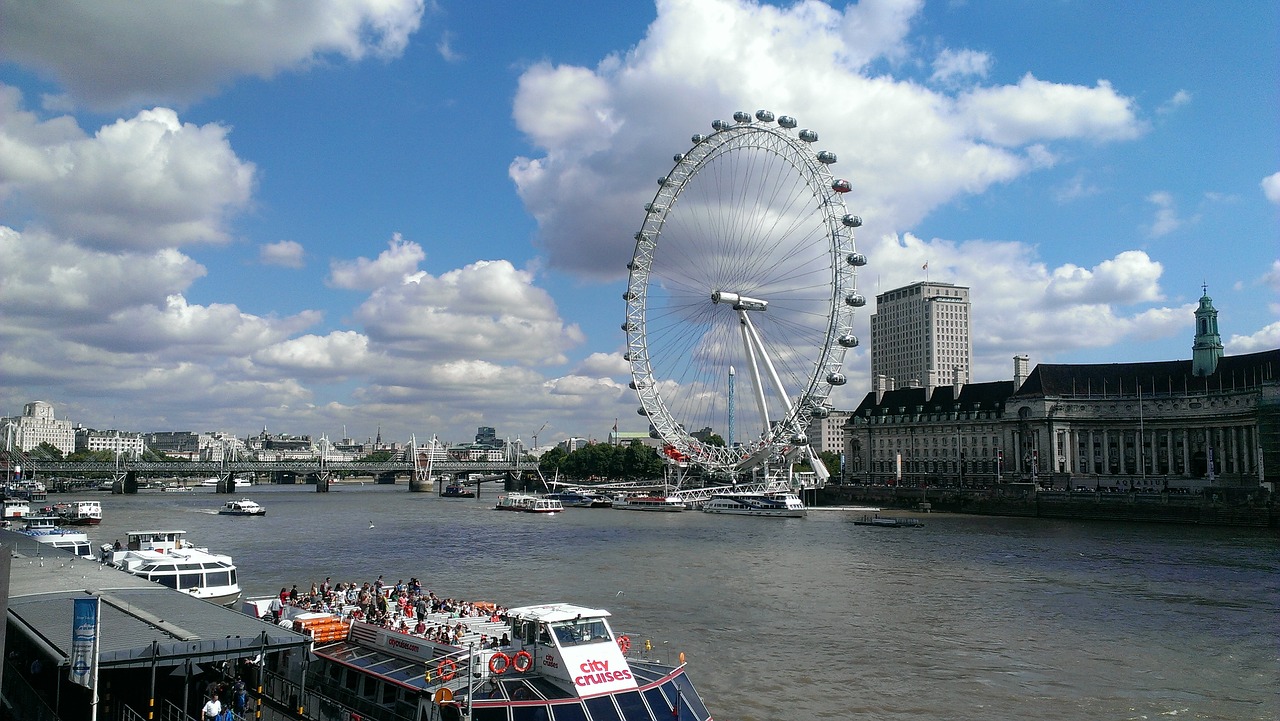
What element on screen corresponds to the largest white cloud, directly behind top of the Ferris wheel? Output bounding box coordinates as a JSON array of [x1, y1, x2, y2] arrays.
[[509, 0, 1143, 279]]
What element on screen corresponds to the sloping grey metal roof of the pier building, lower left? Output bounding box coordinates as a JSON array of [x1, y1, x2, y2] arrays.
[[0, 530, 311, 668]]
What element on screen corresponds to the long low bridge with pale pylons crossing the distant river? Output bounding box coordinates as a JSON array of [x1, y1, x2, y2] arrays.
[[22, 453, 538, 493]]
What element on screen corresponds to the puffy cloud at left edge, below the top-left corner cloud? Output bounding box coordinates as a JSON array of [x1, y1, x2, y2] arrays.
[[0, 87, 256, 250]]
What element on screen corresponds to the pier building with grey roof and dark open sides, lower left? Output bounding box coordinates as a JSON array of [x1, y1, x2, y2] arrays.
[[0, 530, 311, 720]]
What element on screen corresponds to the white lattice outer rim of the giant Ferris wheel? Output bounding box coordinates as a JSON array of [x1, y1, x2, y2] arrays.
[[623, 111, 865, 470]]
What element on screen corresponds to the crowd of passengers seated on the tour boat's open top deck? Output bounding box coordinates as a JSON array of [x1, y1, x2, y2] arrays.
[[270, 576, 511, 648]]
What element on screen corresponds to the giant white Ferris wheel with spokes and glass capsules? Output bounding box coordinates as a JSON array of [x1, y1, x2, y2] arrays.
[[622, 110, 867, 475]]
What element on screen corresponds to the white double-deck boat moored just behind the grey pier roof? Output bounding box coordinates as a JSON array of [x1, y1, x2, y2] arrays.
[[102, 530, 241, 606]]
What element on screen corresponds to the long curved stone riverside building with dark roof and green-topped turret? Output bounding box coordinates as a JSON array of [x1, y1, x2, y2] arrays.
[[845, 292, 1280, 490]]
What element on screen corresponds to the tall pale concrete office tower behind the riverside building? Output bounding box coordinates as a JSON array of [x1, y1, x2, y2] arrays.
[[872, 282, 973, 388]]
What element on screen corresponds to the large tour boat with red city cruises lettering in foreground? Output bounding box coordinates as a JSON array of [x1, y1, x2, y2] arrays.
[[259, 603, 712, 721]]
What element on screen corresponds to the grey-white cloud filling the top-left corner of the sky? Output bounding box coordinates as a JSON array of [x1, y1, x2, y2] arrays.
[[0, 0, 424, 109]]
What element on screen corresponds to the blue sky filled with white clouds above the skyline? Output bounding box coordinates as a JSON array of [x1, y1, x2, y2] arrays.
[[0, 0, 1280, 444]]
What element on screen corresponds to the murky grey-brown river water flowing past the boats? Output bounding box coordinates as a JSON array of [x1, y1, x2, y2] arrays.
[[85, 484, 1280, 721]]
